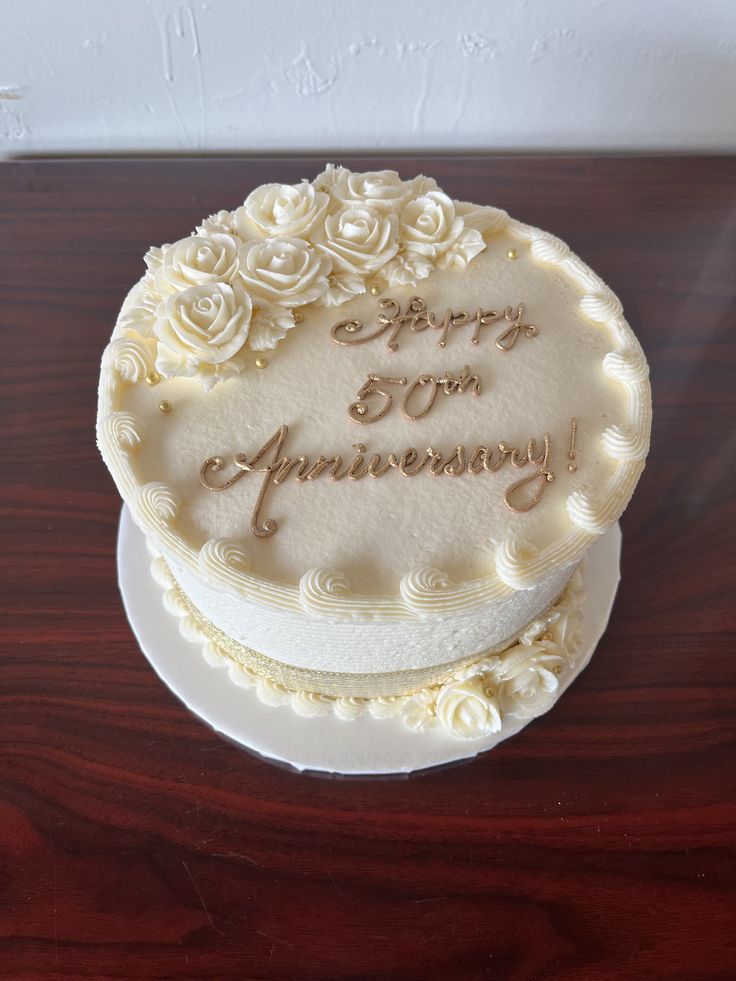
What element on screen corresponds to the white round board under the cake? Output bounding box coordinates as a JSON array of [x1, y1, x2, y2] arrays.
[[117, 507, 621, 775]]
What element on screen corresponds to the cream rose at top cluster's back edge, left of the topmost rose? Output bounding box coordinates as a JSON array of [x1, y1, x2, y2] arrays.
[[235, 181, 328, 239]]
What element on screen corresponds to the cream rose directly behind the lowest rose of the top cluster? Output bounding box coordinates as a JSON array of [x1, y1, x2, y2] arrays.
[[155, 232, 240, 296]]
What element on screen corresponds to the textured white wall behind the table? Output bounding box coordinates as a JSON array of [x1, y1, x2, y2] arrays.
[[0, 0, 736, 156]]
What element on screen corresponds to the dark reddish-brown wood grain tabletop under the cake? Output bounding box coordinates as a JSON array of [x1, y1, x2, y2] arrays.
[[0, 156, 736, 981]]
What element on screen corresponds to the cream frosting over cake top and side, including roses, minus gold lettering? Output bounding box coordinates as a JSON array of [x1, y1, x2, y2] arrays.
[[98, 168, 650, 680]]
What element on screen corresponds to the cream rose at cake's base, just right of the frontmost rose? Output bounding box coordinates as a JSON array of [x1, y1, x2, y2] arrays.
[[498, 644, 565, 718]]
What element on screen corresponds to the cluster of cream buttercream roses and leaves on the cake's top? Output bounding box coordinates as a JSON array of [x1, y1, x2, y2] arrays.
[[124, 164, 504, 388]]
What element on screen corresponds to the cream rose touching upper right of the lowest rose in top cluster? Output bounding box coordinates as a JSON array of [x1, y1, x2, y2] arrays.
[[239, 238, 332, 307]]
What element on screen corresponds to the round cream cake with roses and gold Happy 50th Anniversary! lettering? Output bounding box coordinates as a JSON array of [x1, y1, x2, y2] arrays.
[[97, 165, 651, 739]]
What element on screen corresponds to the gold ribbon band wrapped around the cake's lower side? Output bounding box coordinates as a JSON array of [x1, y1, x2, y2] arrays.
[[166, 564, 564, 698]]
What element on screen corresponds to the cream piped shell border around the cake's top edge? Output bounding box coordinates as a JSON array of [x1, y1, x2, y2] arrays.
[[97, 203, 651, 620]]
